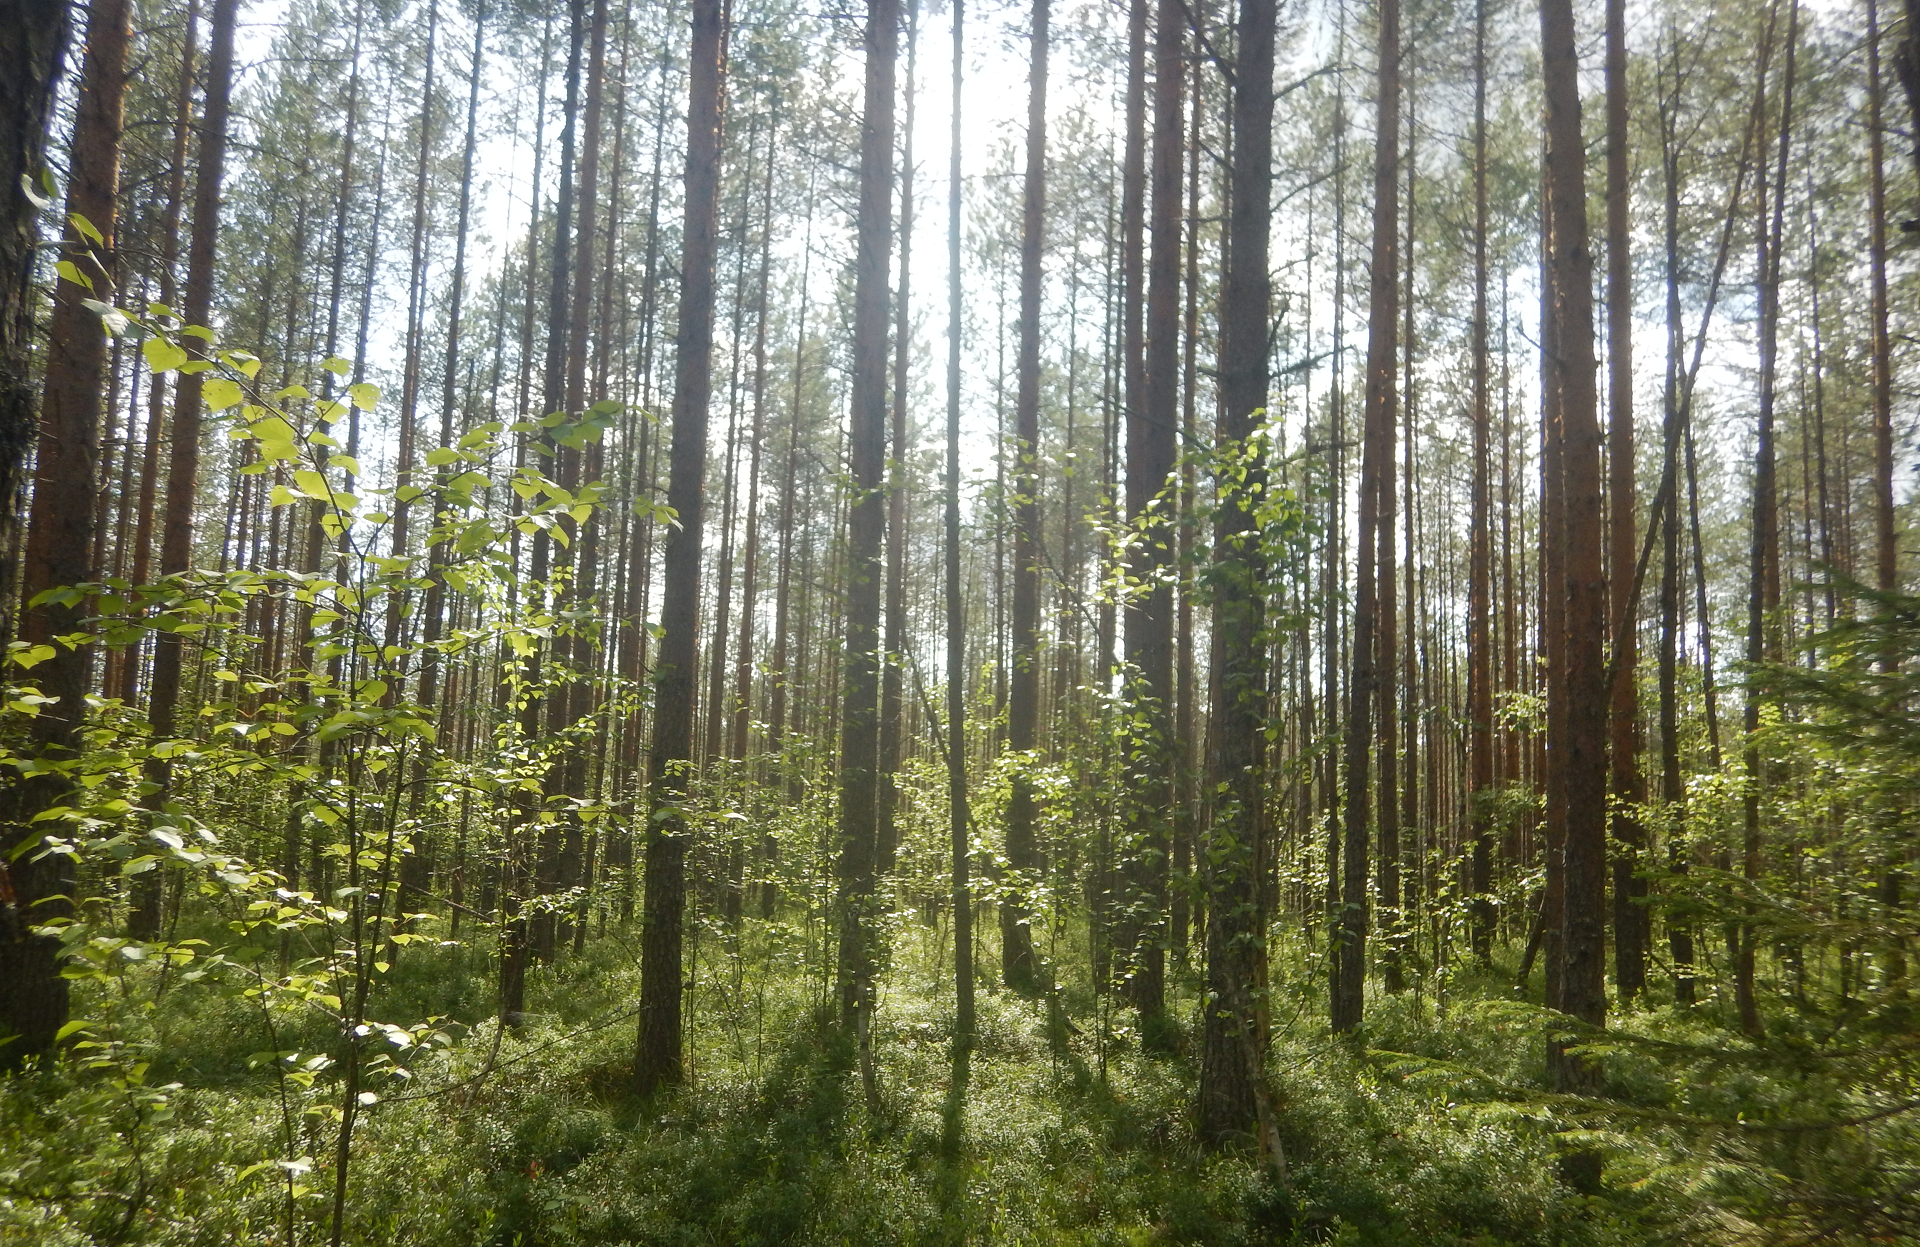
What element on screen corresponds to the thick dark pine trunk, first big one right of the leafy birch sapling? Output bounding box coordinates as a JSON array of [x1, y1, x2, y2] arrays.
[[634, 0, 726, 1095]]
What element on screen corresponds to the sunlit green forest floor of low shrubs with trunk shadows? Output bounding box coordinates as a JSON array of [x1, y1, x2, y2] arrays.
[[0, 903, 1738, 1247]]
